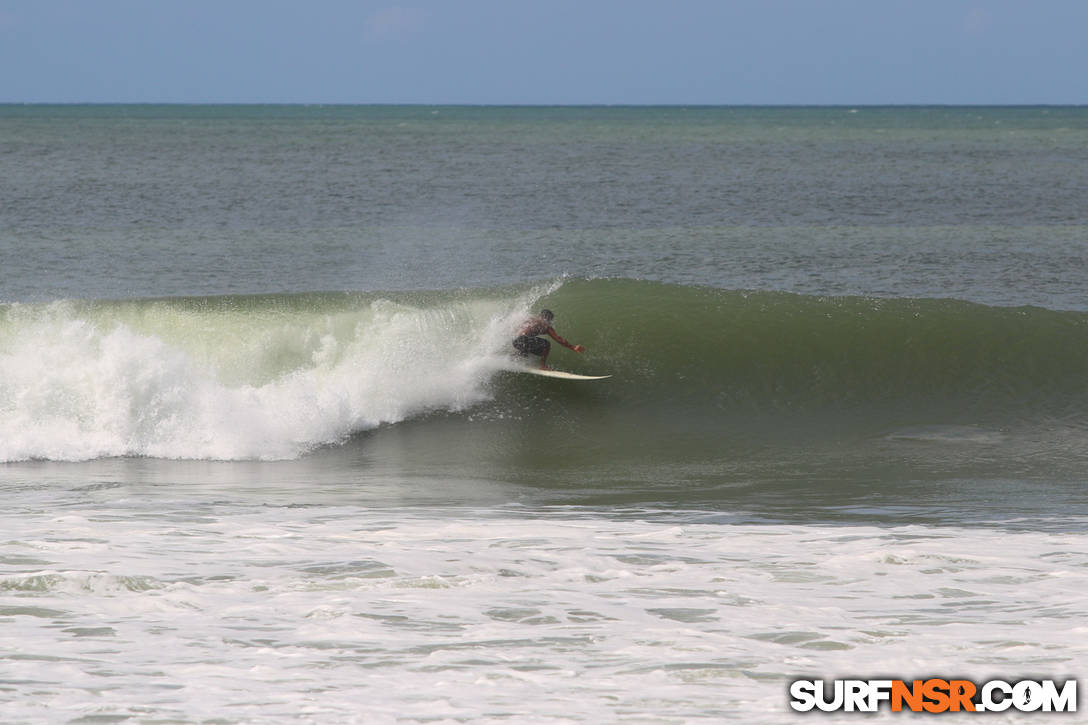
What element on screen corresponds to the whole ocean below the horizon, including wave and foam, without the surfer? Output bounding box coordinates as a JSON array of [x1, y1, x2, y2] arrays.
[[0, 106, 1088, 724]]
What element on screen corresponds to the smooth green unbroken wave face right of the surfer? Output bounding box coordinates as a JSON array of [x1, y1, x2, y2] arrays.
[[542, 280, 1088, 425]]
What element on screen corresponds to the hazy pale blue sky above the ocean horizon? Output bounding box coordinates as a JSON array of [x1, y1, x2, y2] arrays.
[[0, 0, 1088, 105]]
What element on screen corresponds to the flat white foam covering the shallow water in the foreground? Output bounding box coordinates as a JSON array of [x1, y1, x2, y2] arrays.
[[0, 504, 1088, 723]]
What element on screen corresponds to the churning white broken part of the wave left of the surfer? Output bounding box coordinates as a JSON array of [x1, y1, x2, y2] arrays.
[[0, 291, 552, 462]]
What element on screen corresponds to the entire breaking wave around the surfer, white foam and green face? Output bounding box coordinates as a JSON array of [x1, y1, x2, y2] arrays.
[[0, 280, 1088, 462]]
